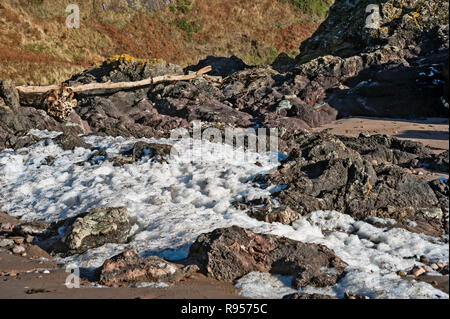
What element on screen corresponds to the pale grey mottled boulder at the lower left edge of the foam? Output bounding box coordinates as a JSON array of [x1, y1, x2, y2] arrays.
[[62, 207, 131, 255]]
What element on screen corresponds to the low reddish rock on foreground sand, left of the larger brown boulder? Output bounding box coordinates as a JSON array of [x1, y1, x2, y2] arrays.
[[95, 250, 184, 287]]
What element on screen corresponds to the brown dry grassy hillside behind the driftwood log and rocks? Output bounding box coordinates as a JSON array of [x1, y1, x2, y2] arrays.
[[0, 0, 330, 85]]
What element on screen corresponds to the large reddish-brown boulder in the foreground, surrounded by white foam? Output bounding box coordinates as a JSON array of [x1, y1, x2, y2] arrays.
[[188, 226, 346, 288]]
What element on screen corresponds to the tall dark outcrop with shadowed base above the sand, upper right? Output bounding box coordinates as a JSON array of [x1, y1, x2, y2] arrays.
[[295, 0, 449, 118]]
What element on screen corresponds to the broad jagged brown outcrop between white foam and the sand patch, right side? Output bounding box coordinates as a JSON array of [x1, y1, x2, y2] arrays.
[[244, 132, 448, 232]]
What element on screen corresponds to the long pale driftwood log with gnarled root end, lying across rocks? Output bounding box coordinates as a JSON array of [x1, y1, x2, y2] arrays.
[[16, 66, 212, 122]]
